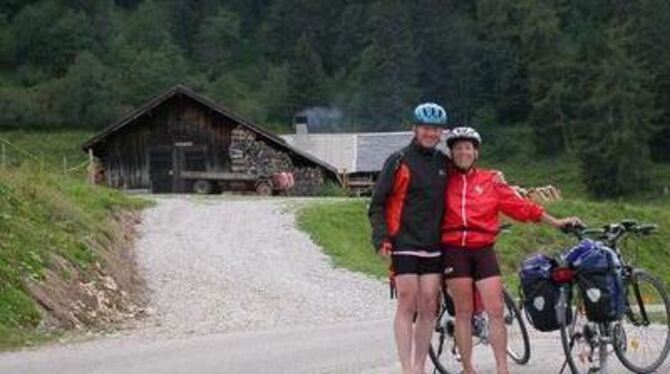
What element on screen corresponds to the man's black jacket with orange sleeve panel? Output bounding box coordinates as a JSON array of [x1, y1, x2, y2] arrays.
[[368, 141, 447, 252]]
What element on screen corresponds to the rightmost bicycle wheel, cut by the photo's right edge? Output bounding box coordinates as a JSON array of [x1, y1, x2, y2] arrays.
[[613, 270, 670, 373]]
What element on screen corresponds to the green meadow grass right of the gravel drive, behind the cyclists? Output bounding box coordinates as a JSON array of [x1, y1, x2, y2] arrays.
[[298, 199, 670, 287]]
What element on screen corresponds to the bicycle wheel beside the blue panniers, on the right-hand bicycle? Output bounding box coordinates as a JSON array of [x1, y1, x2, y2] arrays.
[[557, 286, 602, 374]]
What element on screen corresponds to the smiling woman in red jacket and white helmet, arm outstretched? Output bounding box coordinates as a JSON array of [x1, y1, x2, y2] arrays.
[[442, 127, 581, 374]]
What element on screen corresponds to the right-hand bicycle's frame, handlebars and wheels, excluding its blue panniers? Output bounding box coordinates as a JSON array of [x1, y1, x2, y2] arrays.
[[552, 220, 670, 374]]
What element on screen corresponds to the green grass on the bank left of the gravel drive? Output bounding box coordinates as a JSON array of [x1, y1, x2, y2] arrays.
[[0, 163, 147, 348]]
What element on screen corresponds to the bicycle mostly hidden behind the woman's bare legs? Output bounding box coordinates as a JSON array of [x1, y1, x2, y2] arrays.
[[428, 274, 530, 374]]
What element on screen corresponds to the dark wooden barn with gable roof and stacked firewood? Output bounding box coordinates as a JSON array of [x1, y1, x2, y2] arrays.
[[83, 85, 340, 195]]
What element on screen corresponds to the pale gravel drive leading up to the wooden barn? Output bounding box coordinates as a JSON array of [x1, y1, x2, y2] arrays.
[[138, 197, 394, 335]]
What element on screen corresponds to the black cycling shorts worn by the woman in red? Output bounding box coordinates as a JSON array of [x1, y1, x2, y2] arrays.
[[442, 246, 500, 282]]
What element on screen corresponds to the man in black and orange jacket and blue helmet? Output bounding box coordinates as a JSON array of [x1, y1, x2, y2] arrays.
[[368, 103, 447, 374]]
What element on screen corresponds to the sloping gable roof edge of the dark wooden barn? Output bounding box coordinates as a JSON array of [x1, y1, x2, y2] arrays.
[[82, 84, 340, 180]]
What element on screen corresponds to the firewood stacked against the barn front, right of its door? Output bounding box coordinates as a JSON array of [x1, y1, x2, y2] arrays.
[[228, 126, 324, 195]]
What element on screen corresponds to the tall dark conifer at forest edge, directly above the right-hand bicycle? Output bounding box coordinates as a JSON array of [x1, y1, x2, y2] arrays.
[[579, 21, 656, 197]]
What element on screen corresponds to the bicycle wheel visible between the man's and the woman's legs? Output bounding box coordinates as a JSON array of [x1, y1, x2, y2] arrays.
[[428, 303, 463, 374]]
